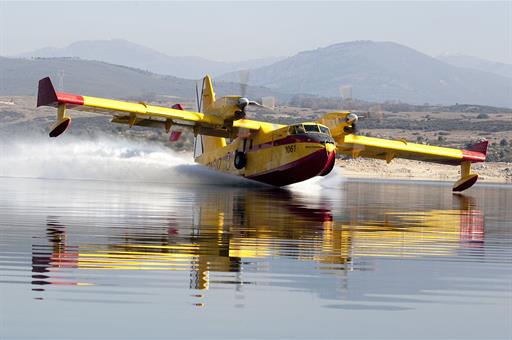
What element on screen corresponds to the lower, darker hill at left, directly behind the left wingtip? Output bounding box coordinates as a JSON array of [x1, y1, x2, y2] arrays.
[[0, 57, 286, 100]]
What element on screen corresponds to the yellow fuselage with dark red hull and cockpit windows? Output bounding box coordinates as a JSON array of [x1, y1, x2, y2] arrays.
[[195, 123, 336, 186]]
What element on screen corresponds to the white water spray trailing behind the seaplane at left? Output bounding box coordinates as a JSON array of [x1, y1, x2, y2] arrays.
[[0, 136, 254, 186]]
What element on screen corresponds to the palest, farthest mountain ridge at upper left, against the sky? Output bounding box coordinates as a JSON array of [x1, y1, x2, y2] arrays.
[[15, 39, 282, 79]]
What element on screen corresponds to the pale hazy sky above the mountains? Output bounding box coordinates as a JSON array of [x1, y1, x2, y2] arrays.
[[0, 0, 512, 63]]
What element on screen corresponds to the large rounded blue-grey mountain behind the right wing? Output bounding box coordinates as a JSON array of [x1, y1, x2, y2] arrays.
[[220, 41, 512, 107]]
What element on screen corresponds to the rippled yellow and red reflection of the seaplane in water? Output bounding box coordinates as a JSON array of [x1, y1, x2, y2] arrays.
[[32, 190, 484, 290]]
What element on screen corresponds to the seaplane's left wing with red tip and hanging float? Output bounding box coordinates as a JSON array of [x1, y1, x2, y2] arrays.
[[37, 77, 263, 137]]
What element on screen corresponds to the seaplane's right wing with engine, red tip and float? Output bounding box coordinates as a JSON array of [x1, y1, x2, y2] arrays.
[[319, 112, 488, 191]]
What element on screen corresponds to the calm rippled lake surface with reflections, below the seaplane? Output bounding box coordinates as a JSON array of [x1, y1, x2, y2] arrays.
[[0, 178, 512, 339]]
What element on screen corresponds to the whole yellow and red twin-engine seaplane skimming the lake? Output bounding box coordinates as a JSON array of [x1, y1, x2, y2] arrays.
[[37, 76, 487, 191]]
